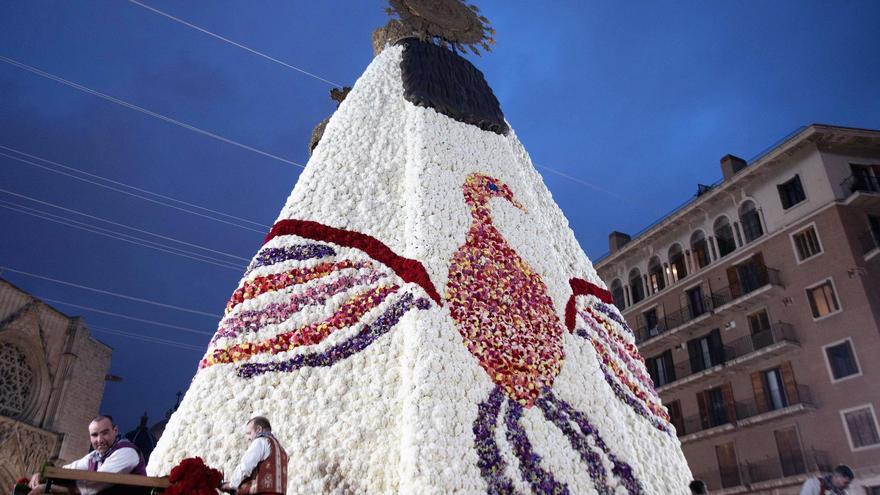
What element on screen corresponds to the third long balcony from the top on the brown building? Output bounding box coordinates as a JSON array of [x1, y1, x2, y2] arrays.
[[677, 385, 815, 443]]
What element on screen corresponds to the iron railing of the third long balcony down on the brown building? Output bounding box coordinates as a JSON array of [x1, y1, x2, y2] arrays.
[[676, 384, 815, 436]]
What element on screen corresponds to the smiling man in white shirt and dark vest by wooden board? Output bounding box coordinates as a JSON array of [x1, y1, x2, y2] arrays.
[[30, 415, 147, 495]]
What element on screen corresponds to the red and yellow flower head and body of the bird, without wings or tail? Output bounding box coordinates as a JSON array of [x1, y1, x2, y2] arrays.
[[445, 174, 564, 407]]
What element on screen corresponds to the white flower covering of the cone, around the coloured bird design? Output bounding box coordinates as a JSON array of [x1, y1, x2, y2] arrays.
[[148, 47, 691, 494]]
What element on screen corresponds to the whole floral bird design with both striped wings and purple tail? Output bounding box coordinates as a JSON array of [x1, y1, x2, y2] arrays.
[[200, 173, 674, 495]]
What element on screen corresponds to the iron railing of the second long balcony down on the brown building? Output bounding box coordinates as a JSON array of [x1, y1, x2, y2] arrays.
[[654, 321, 798, 388]]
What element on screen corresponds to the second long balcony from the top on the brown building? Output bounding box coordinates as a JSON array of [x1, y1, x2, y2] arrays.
[[657, 321, 800, 393]]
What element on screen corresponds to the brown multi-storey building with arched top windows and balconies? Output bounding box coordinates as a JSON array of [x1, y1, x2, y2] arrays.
[[596, 125, 880, 495]]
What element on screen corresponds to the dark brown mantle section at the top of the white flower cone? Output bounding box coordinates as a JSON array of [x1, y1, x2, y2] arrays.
[[397, 38, 508, 134]]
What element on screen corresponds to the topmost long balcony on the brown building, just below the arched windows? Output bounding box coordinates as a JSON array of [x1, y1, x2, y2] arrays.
[[634, 266, 782, 348]]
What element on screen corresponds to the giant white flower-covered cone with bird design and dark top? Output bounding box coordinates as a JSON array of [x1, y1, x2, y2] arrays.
[[149, 35, 690, 494]]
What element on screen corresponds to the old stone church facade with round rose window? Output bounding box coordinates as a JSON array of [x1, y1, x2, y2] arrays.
[[0, 279, 112, 490]]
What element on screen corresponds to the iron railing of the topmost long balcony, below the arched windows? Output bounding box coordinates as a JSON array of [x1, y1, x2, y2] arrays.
[[634, 265, 782, 344]]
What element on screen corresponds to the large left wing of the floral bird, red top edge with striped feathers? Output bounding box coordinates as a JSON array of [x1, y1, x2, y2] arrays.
[[199, 220, 440, 378]]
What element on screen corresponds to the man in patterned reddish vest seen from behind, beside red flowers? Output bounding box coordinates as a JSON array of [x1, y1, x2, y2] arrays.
[[220, 416, 287, 495]]
